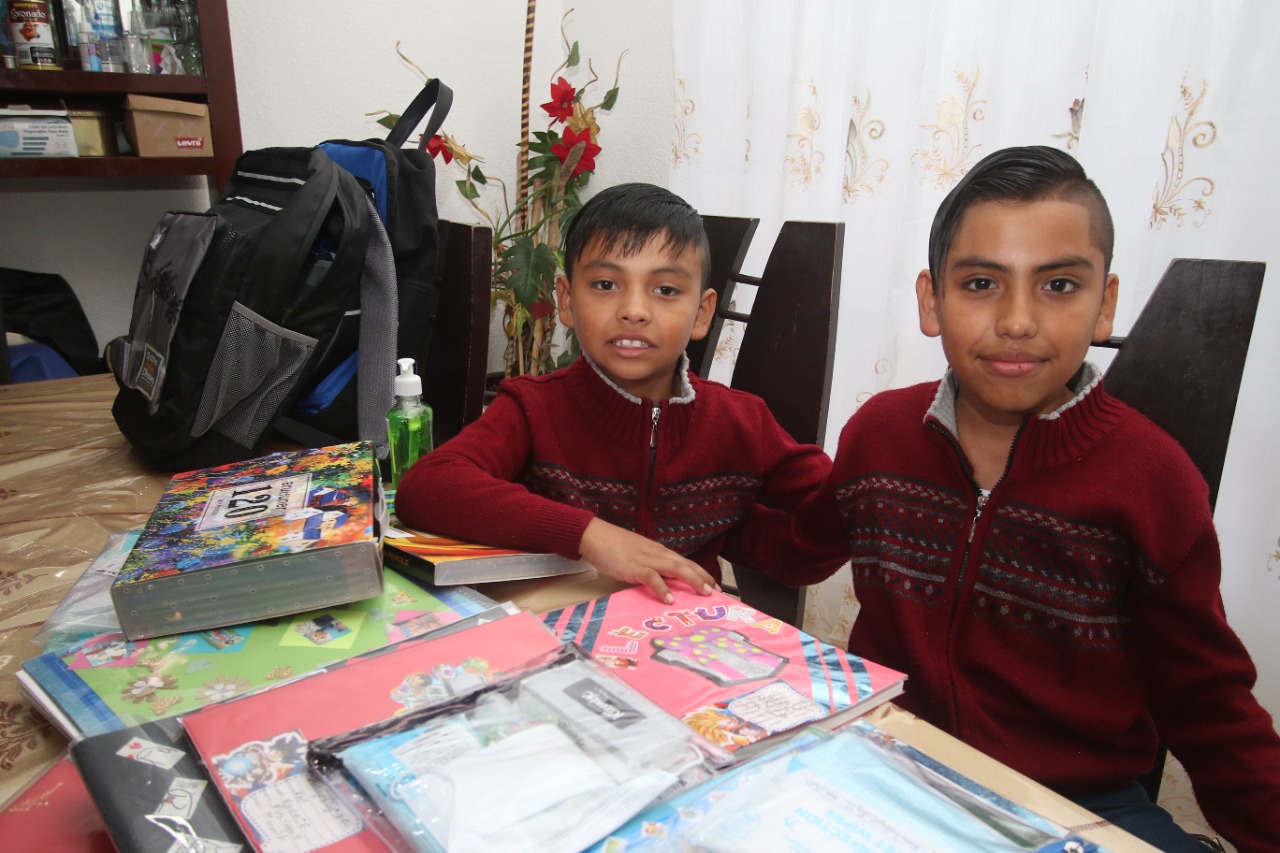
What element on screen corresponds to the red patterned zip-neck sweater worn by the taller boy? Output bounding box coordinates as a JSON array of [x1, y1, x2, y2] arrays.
[[791, 368, 1280, 850]]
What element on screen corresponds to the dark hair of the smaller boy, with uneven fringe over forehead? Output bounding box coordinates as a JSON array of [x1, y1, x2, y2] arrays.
[[564, 183, 710, 291]]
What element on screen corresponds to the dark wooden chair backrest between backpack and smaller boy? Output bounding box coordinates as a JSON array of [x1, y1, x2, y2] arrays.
[[419, 220, 493, 446]]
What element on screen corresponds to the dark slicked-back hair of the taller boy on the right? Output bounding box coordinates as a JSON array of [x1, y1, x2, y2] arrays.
[[929, 145, 1115, 281]]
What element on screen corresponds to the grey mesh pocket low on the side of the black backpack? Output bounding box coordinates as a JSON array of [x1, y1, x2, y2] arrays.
[[191, 302, 316, 447]]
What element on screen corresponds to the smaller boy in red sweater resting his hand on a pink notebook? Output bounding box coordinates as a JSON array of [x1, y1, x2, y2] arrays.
[[396, 183, 840, 601]]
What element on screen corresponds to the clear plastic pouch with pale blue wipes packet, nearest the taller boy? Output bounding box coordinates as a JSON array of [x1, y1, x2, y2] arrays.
[[589, 722, 1098, 853]]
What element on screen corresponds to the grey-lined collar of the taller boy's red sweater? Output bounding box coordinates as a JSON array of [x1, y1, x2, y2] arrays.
[[924, 361, 1123, 469]]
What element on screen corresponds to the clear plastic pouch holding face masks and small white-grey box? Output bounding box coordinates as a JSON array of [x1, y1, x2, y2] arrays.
[[308, 646, 722, 853]]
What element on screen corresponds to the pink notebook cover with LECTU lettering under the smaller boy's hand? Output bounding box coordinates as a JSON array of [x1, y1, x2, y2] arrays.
[[544, 587, 906, 754]]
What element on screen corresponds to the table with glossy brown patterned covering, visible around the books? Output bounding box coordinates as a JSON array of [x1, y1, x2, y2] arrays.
[[0, 375, 1155, 853]]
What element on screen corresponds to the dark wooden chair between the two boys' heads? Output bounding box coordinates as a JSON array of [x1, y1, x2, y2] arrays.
[[689, 216, 845, 626]]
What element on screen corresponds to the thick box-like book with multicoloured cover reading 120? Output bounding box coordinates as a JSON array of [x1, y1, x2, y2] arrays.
[[111, 442, 387, 640]]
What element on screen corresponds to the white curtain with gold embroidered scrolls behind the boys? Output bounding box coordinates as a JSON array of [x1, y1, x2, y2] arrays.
[[671, 0, 1280, 717]]
